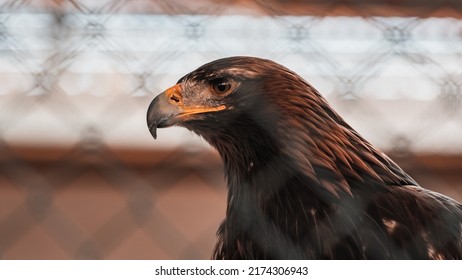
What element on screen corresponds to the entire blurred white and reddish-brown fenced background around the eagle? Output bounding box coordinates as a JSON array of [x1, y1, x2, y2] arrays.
[[0, 0, 462, 259]]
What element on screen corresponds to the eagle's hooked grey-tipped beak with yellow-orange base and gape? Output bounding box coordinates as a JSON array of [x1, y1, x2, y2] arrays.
[[146, 84, 226, 139]]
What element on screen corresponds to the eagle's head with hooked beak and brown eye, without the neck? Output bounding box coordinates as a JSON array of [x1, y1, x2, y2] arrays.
[[147, 57, 300, 140]]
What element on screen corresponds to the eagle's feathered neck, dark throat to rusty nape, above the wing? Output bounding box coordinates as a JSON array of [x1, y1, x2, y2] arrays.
[[200, 95, 415, 259]]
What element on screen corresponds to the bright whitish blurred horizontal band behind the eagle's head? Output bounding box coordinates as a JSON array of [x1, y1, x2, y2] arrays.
[[0, 13, 462, 153]]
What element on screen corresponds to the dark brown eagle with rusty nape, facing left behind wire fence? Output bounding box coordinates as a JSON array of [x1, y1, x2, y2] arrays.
[[147, 56, 462, 259]]
